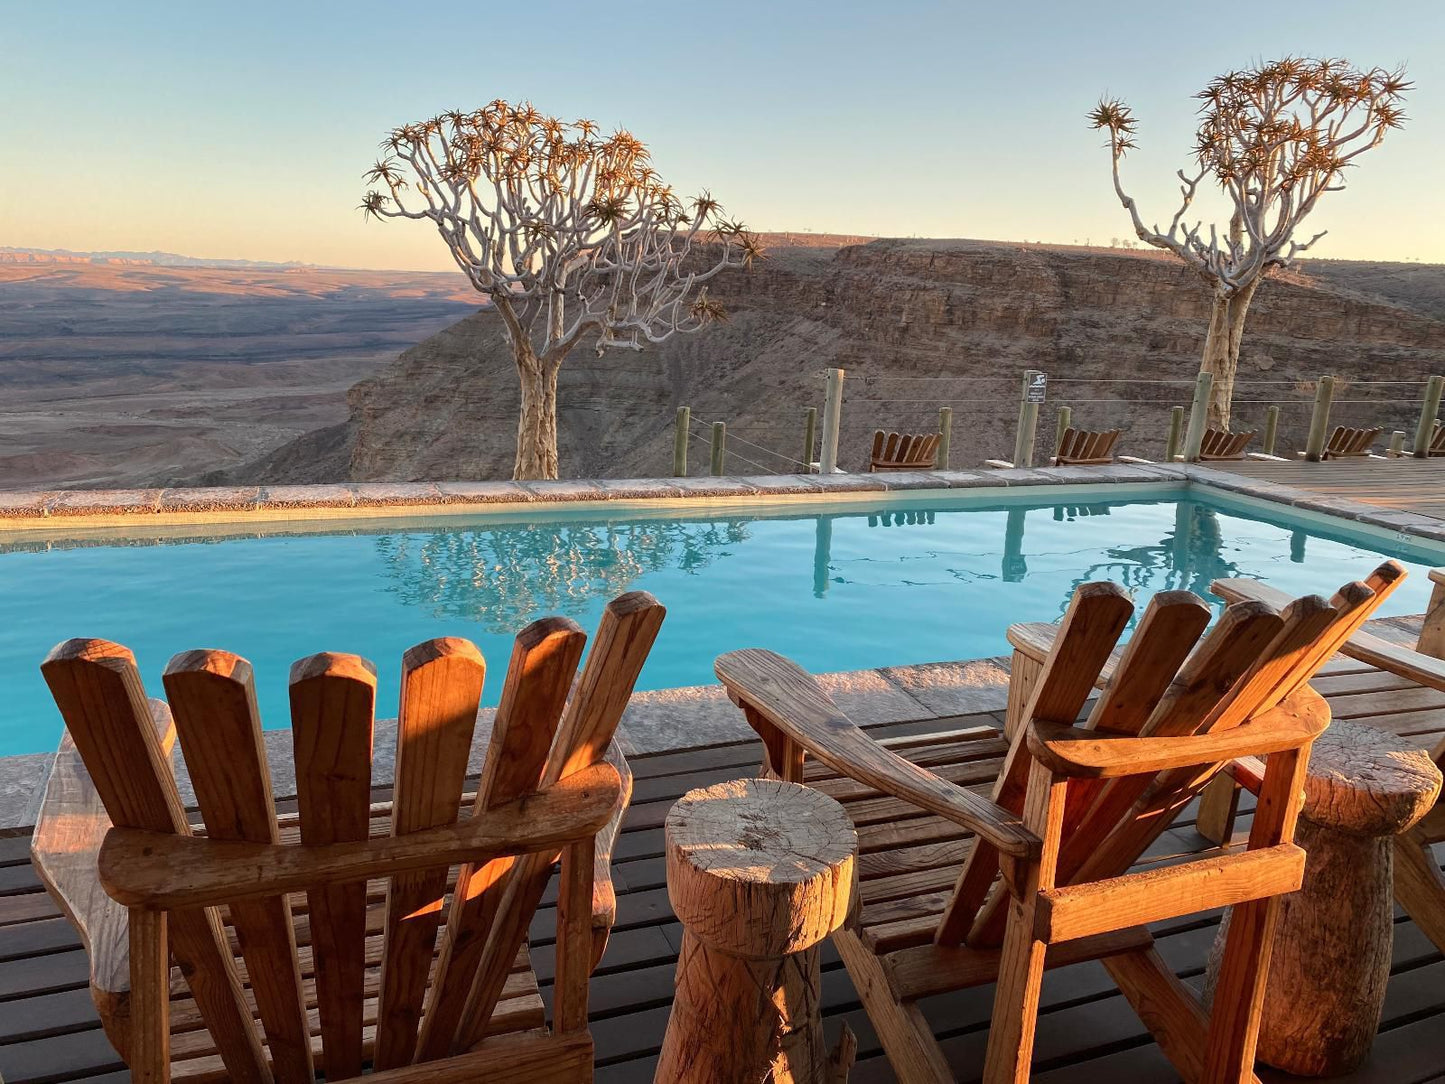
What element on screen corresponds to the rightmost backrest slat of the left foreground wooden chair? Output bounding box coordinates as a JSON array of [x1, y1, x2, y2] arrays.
[[457, 591, 666, 1048]]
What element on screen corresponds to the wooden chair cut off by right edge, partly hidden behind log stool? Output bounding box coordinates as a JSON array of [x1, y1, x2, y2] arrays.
[[1198, 568, 1445, 952]]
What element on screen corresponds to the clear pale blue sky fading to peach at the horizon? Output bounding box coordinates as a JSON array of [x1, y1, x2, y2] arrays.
[[0, 0, 1445, 269]]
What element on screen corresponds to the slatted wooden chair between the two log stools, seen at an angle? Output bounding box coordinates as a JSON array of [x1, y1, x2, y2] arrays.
[[717, 569, 1376, 1084]]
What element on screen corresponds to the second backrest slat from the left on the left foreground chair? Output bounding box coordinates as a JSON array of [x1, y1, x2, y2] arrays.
[[163, 650, 314, 1084]]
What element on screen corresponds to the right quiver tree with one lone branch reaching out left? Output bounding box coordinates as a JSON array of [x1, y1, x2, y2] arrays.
[[1090, 58, 1410, 428]]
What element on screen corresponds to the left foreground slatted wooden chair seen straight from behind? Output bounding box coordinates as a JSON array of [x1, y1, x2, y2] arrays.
[[33, 593, 663, 1084]]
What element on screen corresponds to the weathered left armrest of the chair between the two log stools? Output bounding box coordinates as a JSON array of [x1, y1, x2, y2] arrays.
[[714, 649, 1040, 857]]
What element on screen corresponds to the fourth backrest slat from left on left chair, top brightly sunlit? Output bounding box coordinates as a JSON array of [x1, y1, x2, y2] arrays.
[[376, 637, 487, 1070]]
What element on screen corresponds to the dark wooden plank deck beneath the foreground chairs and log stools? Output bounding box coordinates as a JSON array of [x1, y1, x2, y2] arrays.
[[0, 653, 1445, 1084]]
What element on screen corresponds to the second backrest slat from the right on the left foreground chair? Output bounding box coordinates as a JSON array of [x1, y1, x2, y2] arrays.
[[418, 617, 587, 1059]]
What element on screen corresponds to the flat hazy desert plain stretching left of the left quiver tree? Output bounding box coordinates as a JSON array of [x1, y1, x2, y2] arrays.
[[0, 254, 477, 489]]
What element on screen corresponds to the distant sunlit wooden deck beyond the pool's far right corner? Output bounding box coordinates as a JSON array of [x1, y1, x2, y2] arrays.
[[1202, 457, 1445, 520]]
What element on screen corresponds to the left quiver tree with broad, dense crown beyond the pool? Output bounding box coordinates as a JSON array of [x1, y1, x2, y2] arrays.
[[363, 101, 760, 478]]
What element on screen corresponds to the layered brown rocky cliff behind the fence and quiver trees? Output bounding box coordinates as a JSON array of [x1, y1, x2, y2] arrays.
[[237, 240, 1445, 481]]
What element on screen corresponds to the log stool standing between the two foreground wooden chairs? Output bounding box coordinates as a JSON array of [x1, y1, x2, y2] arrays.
[[655, 779, 858, 1084]]
